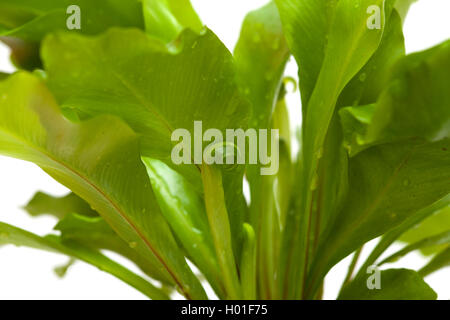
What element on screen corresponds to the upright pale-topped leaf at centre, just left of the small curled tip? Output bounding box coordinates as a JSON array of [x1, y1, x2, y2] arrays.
[[234, 2, 290, 298]]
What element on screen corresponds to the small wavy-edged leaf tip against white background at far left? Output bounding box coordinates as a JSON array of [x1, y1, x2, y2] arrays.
[[24, 192, 98, 219]]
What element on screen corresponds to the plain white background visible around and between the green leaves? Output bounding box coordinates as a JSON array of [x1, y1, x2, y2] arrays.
[[0, 0, 450, 299]]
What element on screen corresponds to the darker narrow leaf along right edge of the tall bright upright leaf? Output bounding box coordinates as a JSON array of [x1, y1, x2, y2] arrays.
[[311, 7, 405, 255]]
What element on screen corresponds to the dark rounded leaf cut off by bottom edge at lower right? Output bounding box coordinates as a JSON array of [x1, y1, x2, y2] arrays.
[[338, 269, 437, 300]]
